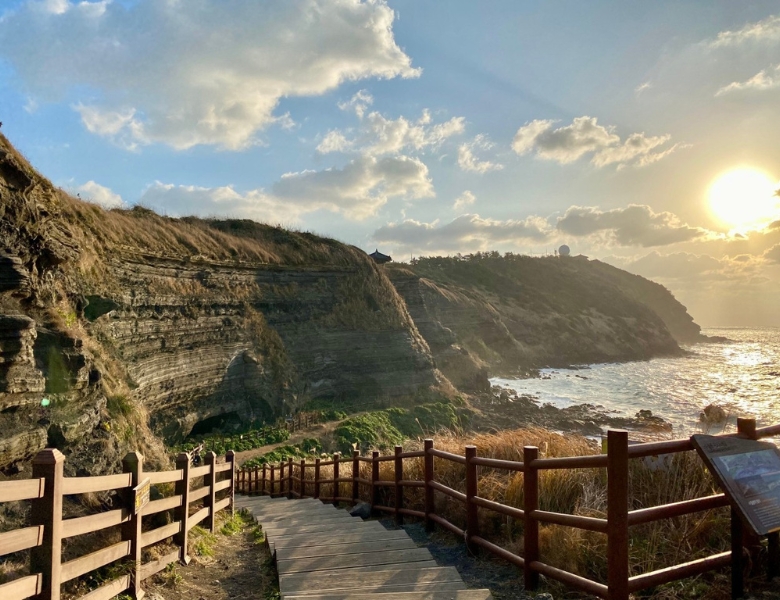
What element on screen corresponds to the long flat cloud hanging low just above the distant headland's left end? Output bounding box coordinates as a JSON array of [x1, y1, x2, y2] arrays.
[[372, 215, 552, 253]]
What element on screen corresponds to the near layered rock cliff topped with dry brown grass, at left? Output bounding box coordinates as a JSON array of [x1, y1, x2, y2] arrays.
[[0, 136, 443, 471]]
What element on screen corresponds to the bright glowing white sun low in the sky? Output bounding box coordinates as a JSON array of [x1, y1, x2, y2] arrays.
[[708, 167, 778, 229]]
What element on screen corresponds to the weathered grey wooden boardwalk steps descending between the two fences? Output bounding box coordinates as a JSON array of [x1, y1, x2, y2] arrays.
[[235, 496, 490, 600]]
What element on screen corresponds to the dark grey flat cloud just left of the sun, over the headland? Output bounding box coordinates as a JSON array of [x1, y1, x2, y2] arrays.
[[557, 204, 709, 247]]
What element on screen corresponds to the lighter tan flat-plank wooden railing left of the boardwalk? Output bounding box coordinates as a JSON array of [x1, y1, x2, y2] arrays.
[[0, 449, 235, 600]]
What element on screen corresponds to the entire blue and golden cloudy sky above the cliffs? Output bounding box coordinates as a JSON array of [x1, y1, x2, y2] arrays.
[[0, 0, 780, 327]]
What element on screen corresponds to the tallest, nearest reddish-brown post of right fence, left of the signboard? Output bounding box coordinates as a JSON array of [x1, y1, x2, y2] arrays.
[[607, 429, 628, 600]]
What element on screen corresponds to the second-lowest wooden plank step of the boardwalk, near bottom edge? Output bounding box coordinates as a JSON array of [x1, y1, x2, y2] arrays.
[[279, 567, 465, 595]]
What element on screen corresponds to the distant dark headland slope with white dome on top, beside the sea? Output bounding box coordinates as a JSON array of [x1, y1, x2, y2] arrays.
[[388, 254, 702, 380]]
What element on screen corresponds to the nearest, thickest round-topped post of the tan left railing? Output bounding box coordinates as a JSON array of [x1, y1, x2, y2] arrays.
[[30, 448, 65, 600]]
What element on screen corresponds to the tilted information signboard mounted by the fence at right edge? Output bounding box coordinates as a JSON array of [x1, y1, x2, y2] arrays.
[[691, 435, 780, 535]]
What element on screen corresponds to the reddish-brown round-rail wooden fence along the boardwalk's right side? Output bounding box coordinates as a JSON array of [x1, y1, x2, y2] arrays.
[[236, 419, 780, 600]]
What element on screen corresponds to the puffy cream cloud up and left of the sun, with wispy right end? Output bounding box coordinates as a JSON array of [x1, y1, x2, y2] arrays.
[[512, 116, 680, 168]]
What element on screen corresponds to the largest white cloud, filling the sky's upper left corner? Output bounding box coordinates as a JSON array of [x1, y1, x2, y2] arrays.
[[0, 0, 420, 149]]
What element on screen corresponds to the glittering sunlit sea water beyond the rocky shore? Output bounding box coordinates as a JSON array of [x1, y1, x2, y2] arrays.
[[491, 328, 780, 437]]
